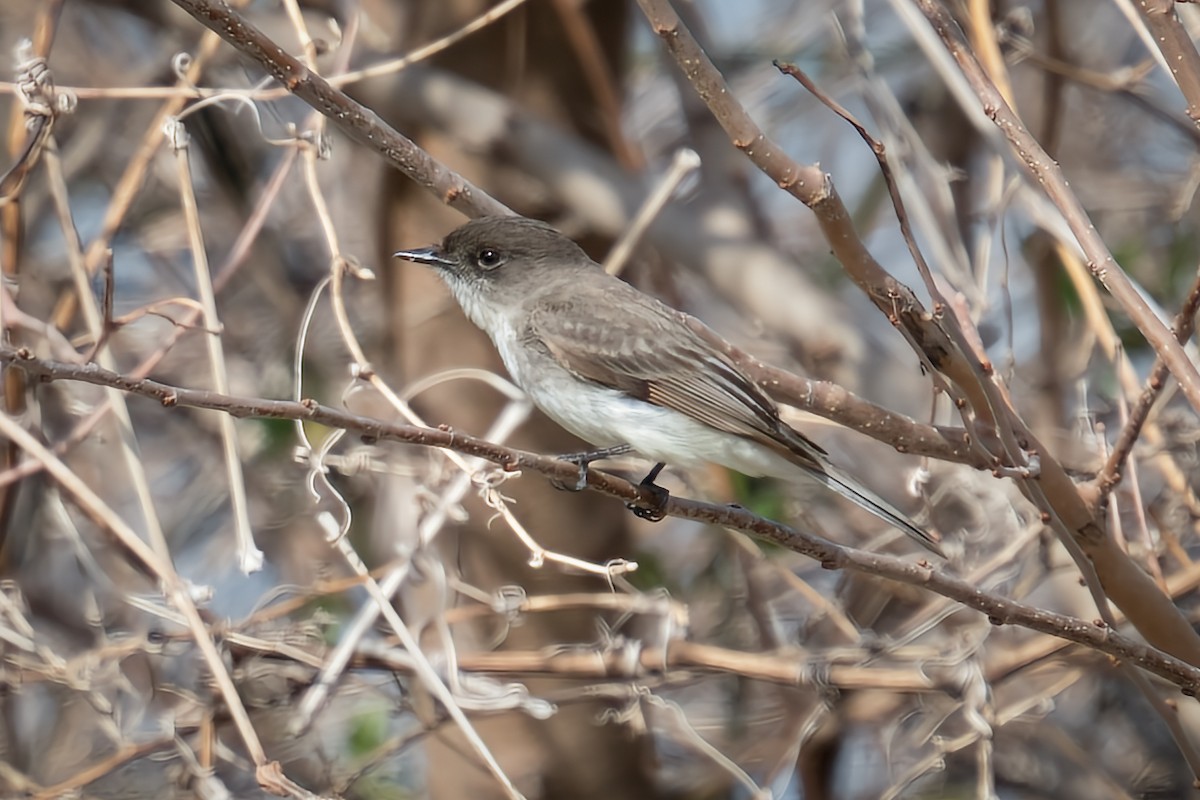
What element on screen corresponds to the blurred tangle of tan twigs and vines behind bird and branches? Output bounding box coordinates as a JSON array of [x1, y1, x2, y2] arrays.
[[0, 0, 1200, 799]]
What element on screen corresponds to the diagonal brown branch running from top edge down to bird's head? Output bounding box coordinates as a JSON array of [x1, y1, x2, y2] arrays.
[[174, 0, 512, 217]]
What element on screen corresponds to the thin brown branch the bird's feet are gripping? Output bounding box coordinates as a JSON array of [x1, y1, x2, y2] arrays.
[[7, 347, 1200, 694]]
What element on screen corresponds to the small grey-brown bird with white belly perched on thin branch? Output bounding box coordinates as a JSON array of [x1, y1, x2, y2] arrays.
[[396, 217, 943, 555]]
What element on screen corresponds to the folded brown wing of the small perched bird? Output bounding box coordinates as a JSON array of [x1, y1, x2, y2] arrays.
[[526, 292, 815, 449]]
